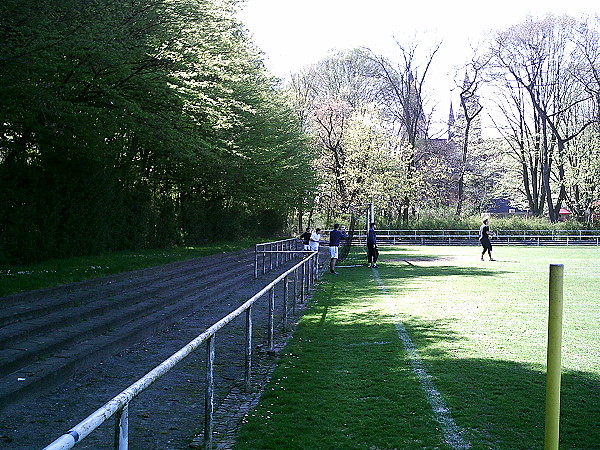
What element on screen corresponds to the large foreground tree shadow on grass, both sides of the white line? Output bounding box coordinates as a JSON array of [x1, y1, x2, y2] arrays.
[[236, 297, 600, 449]]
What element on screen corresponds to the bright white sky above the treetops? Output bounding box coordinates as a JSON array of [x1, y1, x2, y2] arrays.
[[239, 0, 600, 136]]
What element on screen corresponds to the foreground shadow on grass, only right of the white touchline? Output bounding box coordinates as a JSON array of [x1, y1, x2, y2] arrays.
[[396, 319, 600, 449]]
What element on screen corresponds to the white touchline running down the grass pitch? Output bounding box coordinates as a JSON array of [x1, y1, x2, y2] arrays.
[[373, 269, 471, 449]]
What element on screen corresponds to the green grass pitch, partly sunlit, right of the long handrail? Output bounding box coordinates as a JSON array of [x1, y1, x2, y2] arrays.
[[236, 247, 600, 450]]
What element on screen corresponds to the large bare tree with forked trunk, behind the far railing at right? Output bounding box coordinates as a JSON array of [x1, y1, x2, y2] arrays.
[[492, 16, 597, 221]]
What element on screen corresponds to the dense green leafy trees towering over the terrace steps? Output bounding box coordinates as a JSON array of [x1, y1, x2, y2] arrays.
[[0, 0, 315, 262]]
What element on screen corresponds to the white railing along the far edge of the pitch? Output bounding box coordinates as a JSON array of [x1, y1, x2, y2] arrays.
[[352, 229, 600, 246]]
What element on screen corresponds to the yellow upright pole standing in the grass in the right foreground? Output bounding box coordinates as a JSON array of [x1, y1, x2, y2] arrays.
[[544, 264, 564, 450]]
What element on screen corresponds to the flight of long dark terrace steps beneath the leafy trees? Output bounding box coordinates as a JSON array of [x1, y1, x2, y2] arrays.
[[0, 251, 300, 411]]
